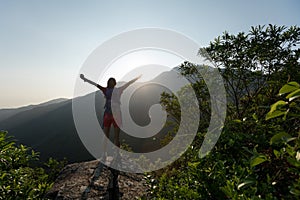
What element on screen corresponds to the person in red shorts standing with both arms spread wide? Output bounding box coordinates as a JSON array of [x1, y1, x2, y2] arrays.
[[80, 74, 141, 153]]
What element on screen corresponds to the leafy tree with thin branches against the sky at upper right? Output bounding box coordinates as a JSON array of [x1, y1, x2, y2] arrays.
[[199, 24, 300, 119]]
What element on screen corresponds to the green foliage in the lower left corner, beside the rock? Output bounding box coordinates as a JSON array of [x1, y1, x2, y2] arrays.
[[0, 131, 65, 199]]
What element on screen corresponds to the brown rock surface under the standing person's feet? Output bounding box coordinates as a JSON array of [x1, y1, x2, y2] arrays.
[[46, 160, 149, 200]]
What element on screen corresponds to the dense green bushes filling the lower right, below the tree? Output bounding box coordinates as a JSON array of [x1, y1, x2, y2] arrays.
[[149, 82, 300, 199]]
